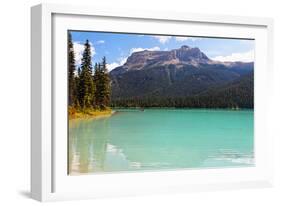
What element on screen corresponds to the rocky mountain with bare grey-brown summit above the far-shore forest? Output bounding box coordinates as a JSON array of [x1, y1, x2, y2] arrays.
[[110, 46, 254, 108]]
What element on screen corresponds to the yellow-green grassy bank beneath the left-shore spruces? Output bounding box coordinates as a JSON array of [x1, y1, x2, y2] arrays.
[[68, 107, 114, 119]]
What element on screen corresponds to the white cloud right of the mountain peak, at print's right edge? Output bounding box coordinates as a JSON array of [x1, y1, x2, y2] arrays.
[[212, 50, 254, 62]]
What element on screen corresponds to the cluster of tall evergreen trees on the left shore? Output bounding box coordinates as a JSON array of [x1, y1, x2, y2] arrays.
[[68, 33, 111, 114]]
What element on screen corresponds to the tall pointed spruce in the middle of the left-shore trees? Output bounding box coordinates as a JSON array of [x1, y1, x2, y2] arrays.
[[79, 40, 95, 109]]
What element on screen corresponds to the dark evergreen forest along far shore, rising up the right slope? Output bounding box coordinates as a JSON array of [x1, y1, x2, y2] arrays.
[[111, 72, 254, 109]]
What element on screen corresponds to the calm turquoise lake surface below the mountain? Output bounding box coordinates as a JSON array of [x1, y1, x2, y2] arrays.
[[69, 109, 254, 175]]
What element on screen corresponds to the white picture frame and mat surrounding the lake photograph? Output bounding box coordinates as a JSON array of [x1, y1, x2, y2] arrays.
[[31, 4, 274, 201]]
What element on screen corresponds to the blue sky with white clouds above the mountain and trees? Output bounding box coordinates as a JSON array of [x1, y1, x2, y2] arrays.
[[71, 31, 254, 70]]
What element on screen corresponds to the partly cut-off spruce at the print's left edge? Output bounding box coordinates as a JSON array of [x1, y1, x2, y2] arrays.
[[68, 32, 76, 106]]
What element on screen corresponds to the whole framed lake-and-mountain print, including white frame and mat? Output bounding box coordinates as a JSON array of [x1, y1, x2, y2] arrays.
[[31, 4, 273, 201]]
